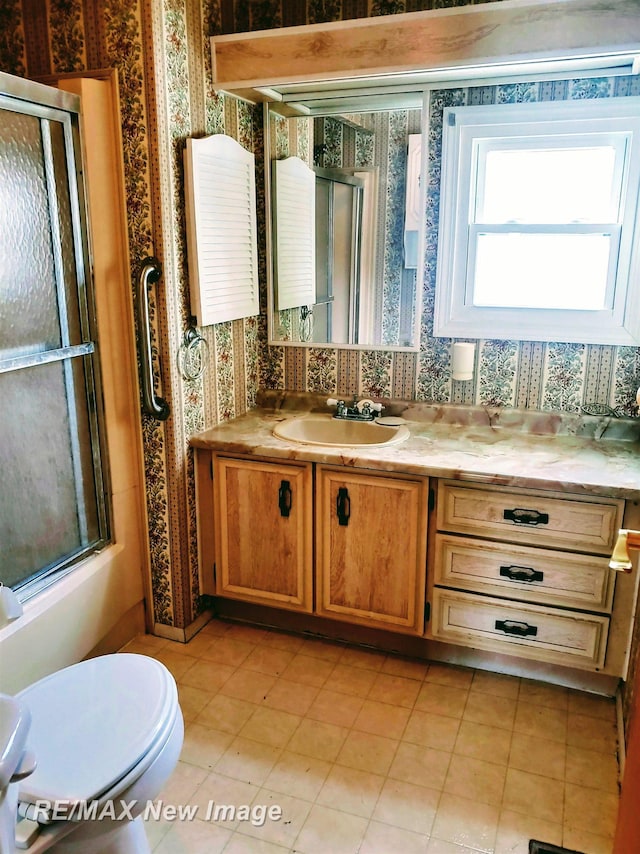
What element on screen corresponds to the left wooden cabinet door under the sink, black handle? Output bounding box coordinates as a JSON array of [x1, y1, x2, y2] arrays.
[[215, 457, 313, 612]]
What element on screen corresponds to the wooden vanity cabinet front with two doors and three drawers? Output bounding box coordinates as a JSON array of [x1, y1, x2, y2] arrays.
[[196, 450, 640, 679]]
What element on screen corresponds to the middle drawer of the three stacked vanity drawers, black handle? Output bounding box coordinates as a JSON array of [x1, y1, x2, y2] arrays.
[[434, 534, 615, 612]]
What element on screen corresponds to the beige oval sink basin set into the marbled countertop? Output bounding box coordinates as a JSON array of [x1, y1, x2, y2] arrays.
[[273, 414, 409, 448]]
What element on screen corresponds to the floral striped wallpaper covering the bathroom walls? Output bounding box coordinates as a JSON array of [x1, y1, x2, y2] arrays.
[[0, 0, 640, 648]]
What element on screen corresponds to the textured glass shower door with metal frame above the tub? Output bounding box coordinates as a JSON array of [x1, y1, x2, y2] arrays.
[[0, 75, 108, 598]]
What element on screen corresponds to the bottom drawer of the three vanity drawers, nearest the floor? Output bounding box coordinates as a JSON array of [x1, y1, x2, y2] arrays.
[[431, 588, 609, 670]]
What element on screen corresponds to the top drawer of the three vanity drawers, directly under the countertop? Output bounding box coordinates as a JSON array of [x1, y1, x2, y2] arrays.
[[437, 481, 624, 555]]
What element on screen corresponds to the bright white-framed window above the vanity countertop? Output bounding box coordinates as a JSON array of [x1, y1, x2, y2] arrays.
[[434, 98, 640, 344]]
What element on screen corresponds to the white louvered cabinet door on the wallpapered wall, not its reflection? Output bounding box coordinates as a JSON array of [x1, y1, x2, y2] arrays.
[[184, 134, 260, 326]]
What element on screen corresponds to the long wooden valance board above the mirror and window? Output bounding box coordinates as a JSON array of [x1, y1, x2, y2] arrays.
[[211, 0, 640, 90]]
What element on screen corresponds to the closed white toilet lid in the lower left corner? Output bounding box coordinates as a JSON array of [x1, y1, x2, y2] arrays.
[[18, 653, 177, 803]]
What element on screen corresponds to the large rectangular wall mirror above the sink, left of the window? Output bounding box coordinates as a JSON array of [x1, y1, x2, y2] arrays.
[[265, 104, 422, 350]]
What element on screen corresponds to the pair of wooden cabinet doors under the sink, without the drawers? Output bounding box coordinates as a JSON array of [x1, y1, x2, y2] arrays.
[[198, 453, 429, 635]]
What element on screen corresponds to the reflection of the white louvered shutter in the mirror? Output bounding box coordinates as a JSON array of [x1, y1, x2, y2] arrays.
[[274, 157, 316, 311]]
